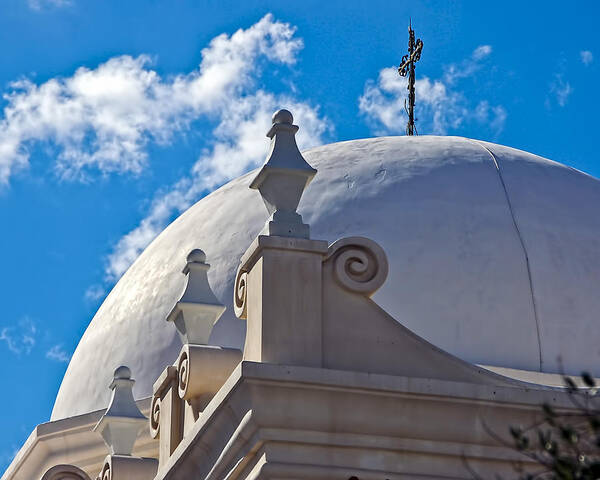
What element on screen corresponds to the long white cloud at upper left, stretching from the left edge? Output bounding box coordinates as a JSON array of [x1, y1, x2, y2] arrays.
[[0, 14, 302, 184]]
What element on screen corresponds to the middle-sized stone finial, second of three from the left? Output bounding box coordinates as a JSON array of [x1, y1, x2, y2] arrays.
[[167, 249, 225, 345]]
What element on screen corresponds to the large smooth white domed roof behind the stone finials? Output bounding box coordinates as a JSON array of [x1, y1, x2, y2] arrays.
[[52, 136, 600, 419]]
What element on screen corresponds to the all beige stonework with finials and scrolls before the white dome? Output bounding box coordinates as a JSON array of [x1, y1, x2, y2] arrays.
[[2, 111, 592, 480]]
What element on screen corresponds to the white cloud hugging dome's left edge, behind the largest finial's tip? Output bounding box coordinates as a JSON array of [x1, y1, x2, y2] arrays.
[[106, 91, 328, 282]]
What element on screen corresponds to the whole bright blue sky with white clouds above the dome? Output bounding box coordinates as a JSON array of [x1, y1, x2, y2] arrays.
[[0, 0, 600, 471]]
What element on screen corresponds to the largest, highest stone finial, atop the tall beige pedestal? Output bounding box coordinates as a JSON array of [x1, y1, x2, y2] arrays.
[[250, 110, 317, 238]]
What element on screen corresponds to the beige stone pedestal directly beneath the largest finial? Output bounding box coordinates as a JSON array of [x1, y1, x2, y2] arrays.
[[235, 235, 328, 367]]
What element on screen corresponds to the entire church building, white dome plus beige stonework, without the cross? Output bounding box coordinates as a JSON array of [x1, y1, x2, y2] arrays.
[[2, 110, 600, 480]]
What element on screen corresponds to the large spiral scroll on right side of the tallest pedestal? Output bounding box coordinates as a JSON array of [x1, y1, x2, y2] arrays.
[[325, 237, 388, 297]]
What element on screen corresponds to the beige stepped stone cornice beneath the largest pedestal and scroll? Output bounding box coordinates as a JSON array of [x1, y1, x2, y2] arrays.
[[157, 362, 571, 480]]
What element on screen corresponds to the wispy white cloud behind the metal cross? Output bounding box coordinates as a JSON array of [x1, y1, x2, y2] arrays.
[[359, 45, 507, 137]]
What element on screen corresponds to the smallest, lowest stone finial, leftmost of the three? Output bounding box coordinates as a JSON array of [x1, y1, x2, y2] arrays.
[[94, 366, 148, 455]]
